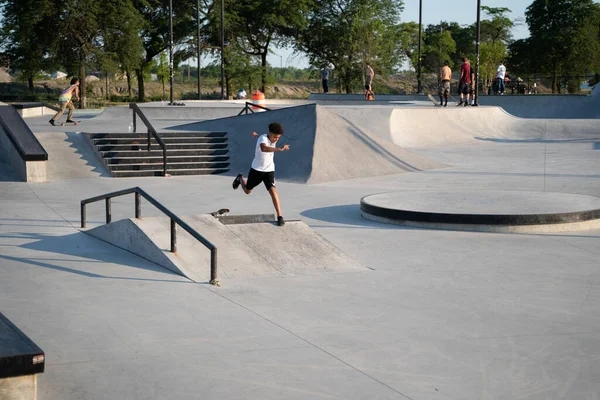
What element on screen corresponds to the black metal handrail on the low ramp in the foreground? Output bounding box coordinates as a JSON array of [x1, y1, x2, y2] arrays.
[[81, 187, 219, 286]]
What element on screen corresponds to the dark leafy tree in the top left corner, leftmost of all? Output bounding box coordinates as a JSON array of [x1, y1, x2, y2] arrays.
[[0, 0, 57, 93]]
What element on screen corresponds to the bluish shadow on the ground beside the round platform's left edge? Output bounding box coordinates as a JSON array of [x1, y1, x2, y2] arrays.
[[300, 204, 414, 230]]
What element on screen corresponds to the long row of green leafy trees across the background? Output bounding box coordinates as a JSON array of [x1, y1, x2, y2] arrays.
[[0, 0, 600, 107]]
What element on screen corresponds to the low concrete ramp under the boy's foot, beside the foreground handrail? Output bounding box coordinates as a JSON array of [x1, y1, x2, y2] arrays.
[[85, 214, 367, 282]]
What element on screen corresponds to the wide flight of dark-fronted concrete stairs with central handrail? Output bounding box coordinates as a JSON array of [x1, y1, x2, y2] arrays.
[[88, 132, 229, 178]]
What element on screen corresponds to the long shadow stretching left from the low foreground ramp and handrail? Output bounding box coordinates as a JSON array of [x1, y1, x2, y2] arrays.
[[0, 232, 199, 284]]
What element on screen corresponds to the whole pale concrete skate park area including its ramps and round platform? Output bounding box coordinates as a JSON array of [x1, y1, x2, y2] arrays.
[[0, 90, 600, 399]]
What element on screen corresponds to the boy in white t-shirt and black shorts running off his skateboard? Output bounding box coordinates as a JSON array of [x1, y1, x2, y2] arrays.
[[232, 122, 290, 226]]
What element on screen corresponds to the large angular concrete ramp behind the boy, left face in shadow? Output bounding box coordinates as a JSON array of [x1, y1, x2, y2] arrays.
[[166, 104, 445, 184]]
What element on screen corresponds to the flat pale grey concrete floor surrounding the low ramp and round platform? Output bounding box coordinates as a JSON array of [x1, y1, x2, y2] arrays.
[[0, 97, 600, 400]]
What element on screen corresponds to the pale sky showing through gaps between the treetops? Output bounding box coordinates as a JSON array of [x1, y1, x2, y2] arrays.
[[267, 0, 533, 68]]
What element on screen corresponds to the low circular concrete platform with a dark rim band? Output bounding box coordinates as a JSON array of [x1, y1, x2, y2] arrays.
[[360, 190, 600, 233]]
